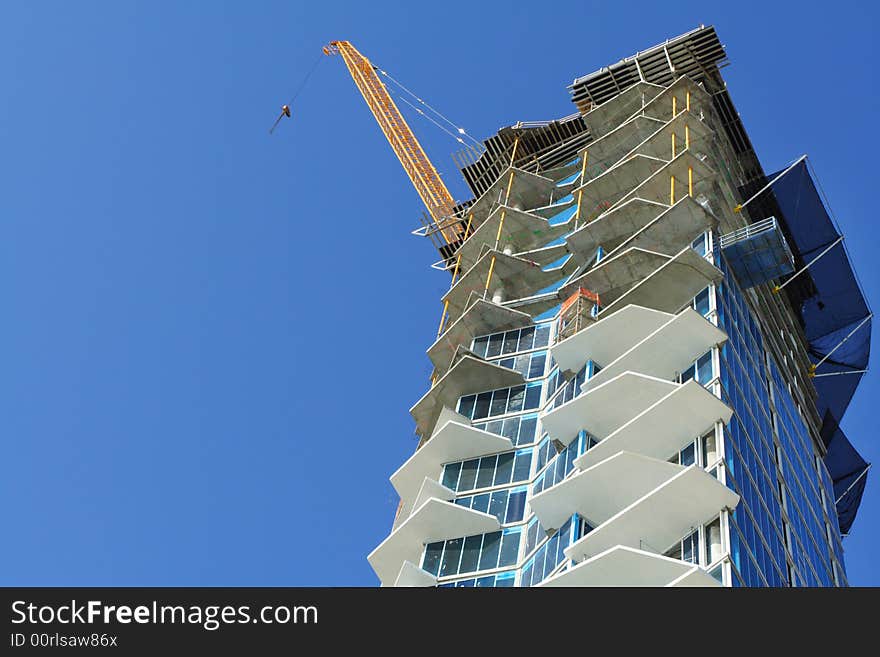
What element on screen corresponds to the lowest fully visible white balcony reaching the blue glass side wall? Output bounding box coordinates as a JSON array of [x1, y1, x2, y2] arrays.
[[565, 465, 739, 561]]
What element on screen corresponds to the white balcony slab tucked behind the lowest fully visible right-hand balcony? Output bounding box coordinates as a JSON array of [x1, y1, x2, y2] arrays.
[[530, 452, 685, 529]]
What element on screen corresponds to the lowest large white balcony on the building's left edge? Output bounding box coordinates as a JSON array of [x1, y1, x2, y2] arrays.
[[367, 499, 500, 586]]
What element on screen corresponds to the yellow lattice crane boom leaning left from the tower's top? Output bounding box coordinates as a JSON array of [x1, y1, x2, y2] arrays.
[[324, 41, 462, 245]]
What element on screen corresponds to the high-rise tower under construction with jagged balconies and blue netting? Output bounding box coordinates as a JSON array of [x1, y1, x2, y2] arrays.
[[368, 26, 871, 586]]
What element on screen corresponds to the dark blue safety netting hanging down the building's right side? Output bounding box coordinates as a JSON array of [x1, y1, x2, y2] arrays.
[[767, 160, 871, 533]]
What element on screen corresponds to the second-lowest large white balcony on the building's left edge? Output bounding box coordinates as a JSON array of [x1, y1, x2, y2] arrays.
[[391, 416, 513, 512]]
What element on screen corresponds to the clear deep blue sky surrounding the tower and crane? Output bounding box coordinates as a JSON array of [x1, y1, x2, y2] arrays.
[[0, 0, 880, 585]]
